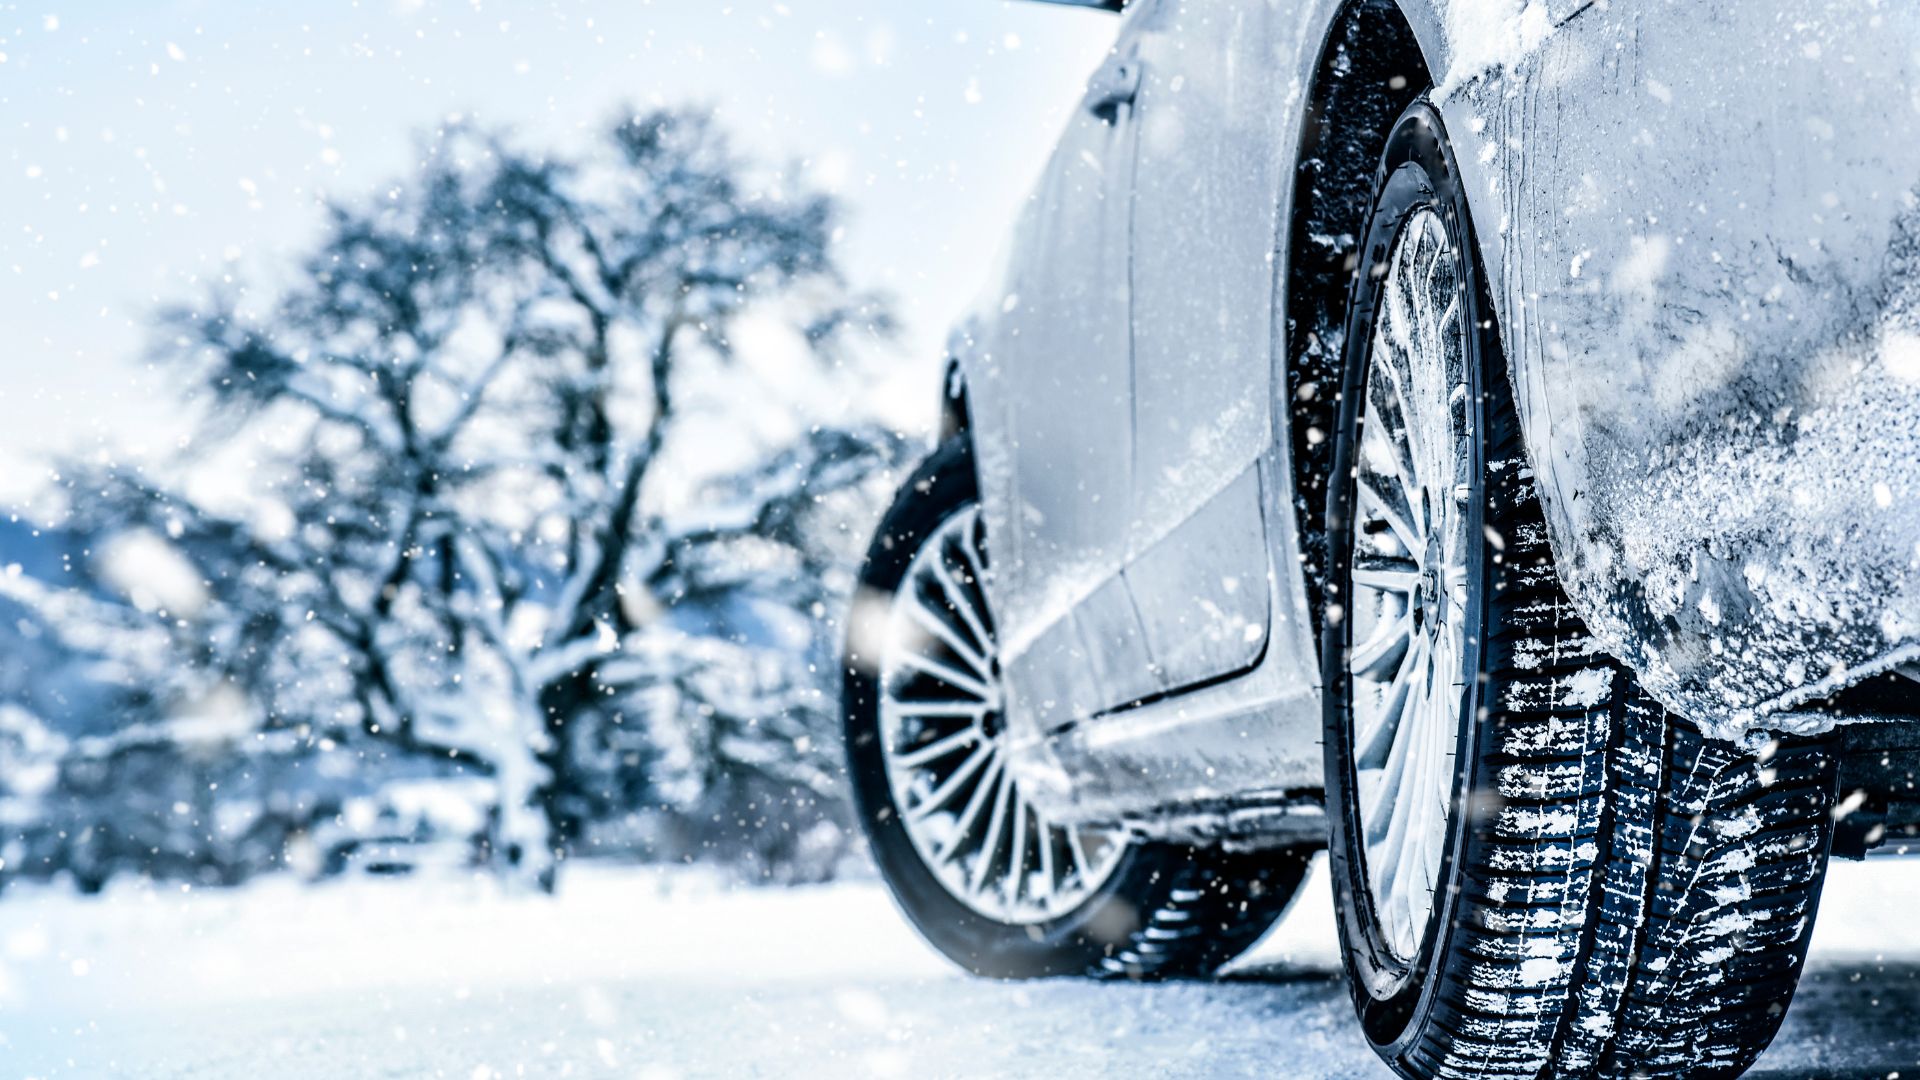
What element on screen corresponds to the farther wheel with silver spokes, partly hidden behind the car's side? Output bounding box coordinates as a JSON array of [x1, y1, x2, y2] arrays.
[[845, 438, 1306, 978]]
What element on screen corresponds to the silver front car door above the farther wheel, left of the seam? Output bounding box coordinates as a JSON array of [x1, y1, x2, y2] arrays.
[[968, 15, 1160, 728]]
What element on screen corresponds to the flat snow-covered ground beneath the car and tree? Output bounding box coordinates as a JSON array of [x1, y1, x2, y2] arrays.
[[0, 863, 1920, 1080]]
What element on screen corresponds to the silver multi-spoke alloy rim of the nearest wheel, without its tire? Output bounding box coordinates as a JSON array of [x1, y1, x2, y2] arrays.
[[1346, 209, 1482, 963]]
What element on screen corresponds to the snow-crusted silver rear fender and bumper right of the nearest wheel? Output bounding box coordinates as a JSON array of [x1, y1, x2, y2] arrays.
[[1443, 0, 1920, 736]]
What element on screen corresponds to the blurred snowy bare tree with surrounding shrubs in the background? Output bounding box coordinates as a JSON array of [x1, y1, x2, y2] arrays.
[[0, 110, 916, 890]]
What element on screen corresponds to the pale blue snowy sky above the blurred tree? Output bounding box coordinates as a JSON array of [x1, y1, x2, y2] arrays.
[[0, 0, 1114, 498]]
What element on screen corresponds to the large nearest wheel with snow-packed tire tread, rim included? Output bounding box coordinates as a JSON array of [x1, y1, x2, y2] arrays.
[[1323, 102, 1834, 1080]]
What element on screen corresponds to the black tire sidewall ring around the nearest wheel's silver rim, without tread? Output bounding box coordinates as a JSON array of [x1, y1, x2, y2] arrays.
[[1321, 100, 1500, 1061]]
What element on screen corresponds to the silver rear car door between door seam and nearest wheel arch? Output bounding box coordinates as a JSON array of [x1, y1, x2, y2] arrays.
[[1127, 0, 1286, 688]]
